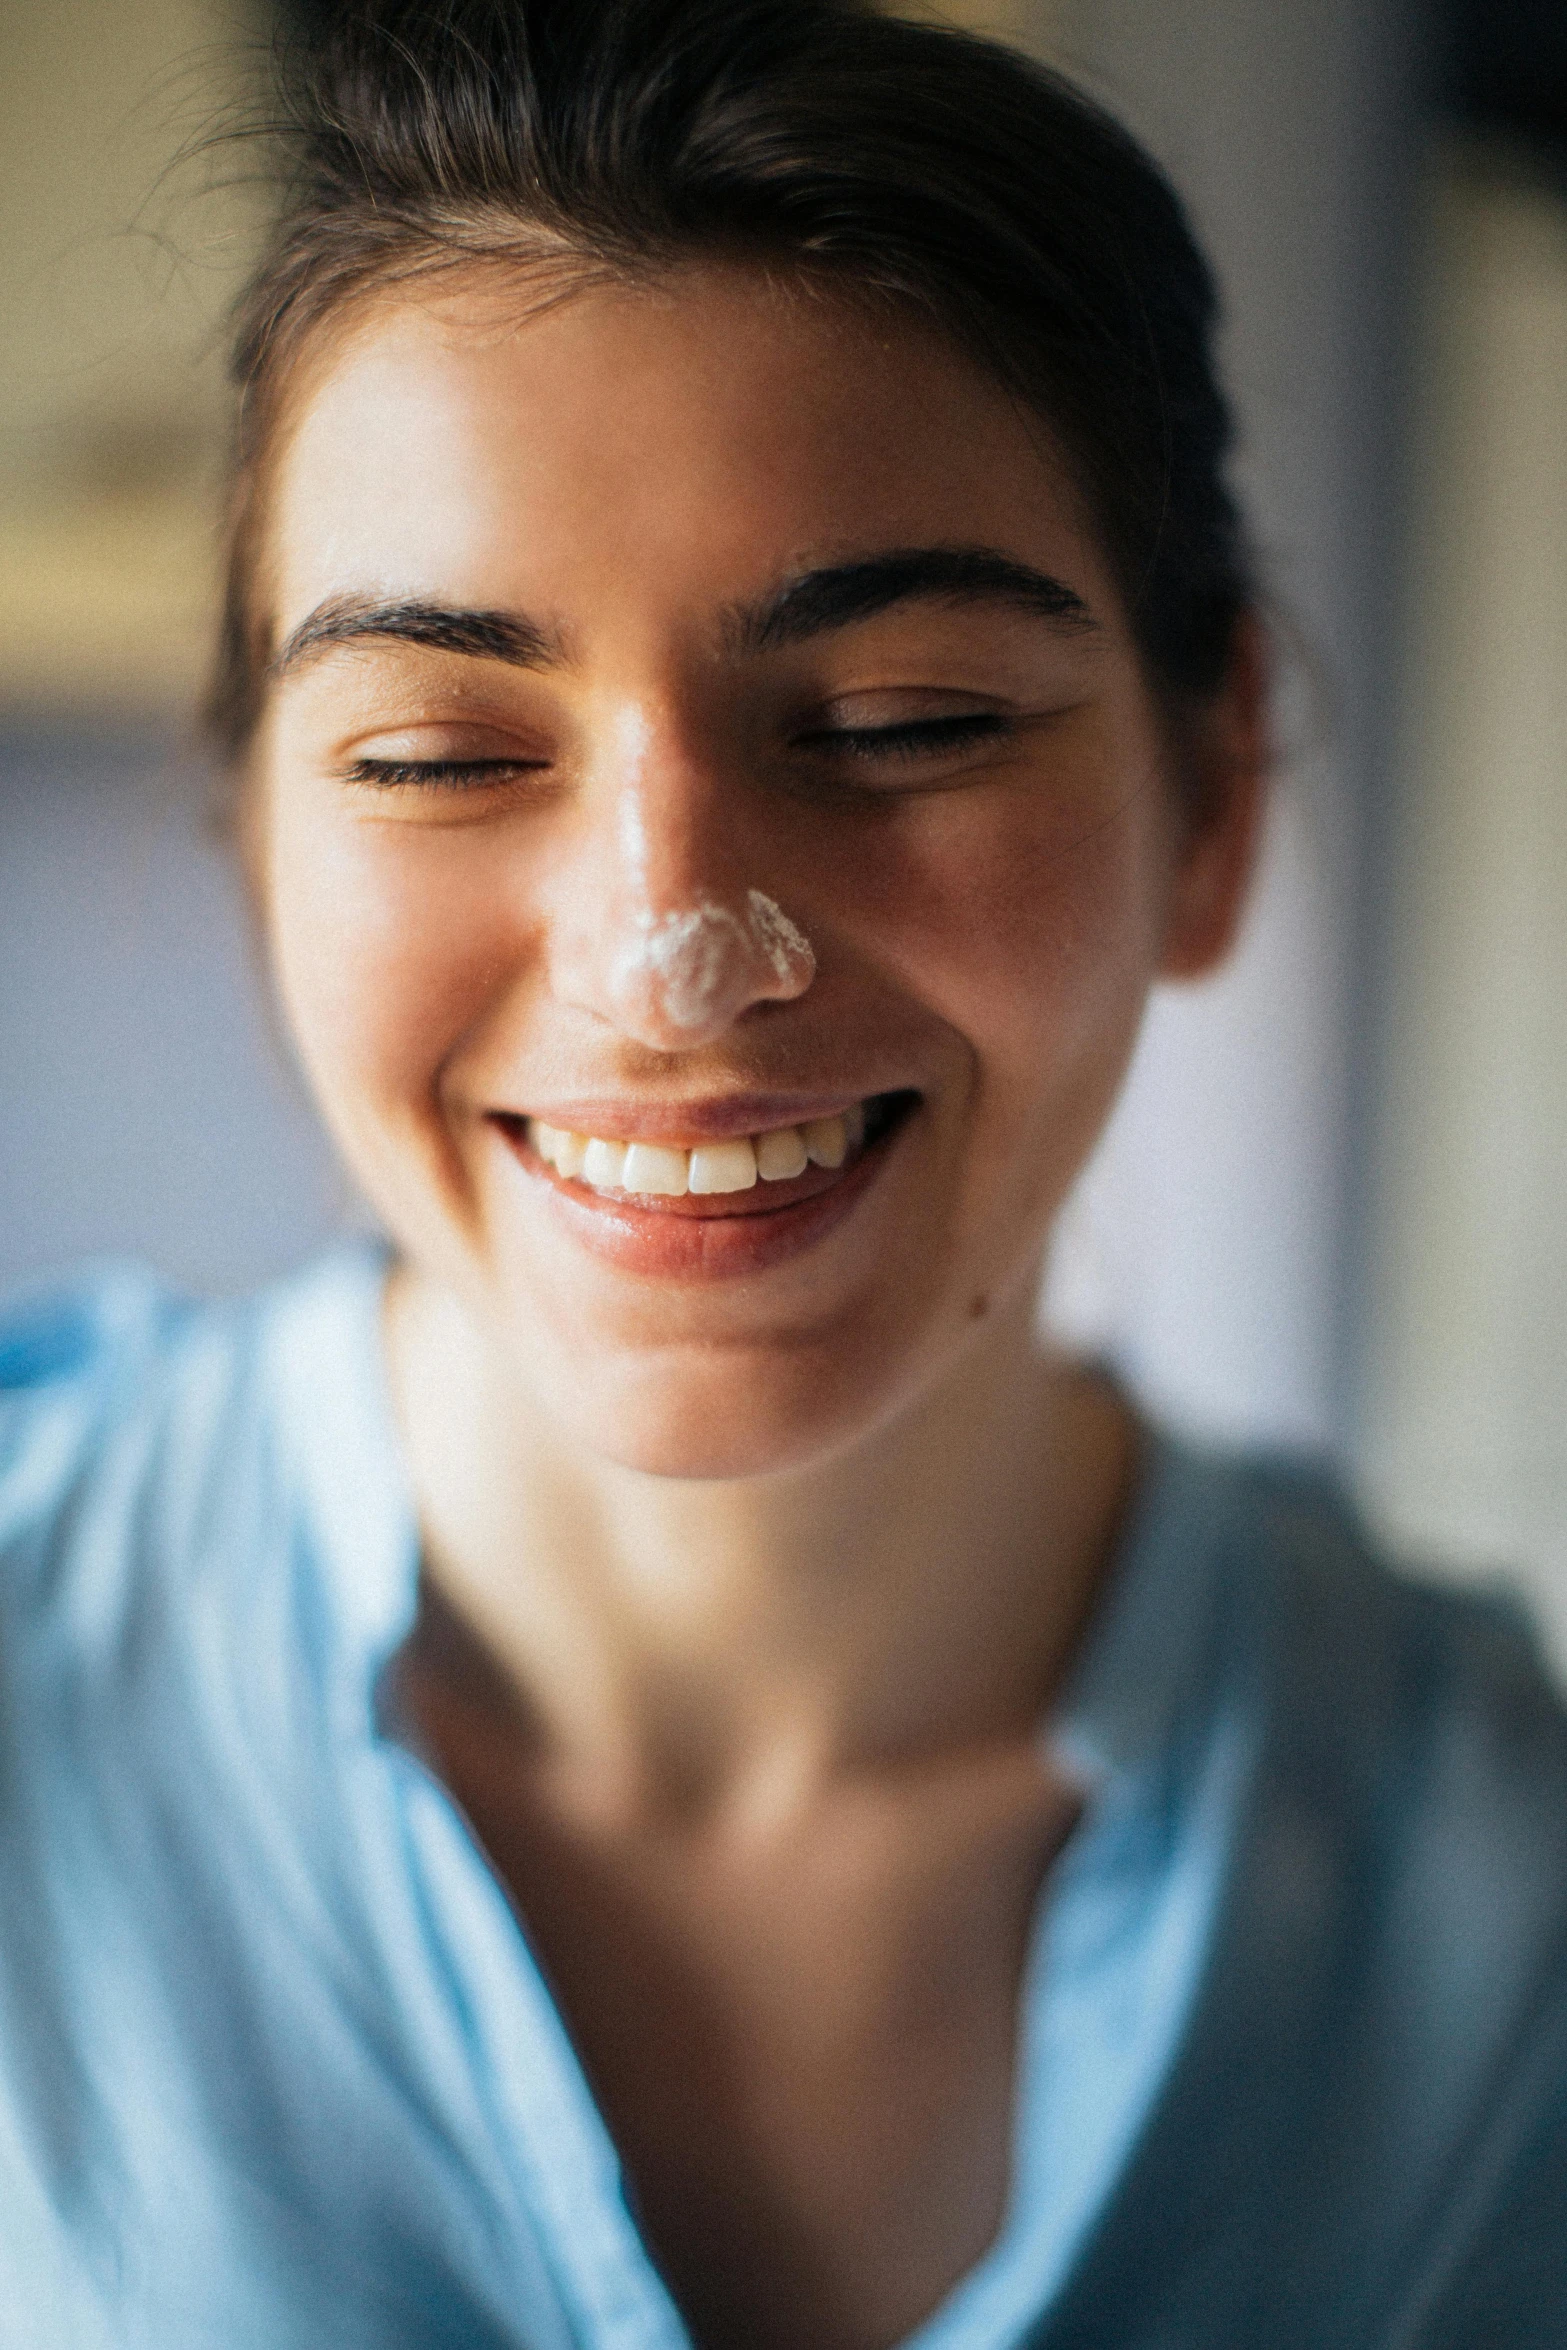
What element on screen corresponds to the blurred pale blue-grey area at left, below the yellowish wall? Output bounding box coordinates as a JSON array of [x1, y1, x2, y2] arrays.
[[0, 726, 352, 1290]]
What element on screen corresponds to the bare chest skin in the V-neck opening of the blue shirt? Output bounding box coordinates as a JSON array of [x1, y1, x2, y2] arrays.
[[399, 1597, 1076, 2350]]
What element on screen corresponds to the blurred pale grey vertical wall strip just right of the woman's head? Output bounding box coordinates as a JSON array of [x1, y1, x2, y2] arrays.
[[1029, 0, 1431, 1450]]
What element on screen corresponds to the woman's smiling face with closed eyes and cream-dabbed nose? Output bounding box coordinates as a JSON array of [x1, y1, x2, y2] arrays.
[[251, 257, 1243, 1476]]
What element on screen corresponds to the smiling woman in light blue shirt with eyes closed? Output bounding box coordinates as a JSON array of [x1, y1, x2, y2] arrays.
[[0, 0, 1567, 2350]]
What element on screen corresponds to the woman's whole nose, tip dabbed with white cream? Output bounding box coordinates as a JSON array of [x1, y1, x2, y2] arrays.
[[557, 710, 815, 1053]]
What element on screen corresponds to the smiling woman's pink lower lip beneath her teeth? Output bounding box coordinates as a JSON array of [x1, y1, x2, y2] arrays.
[[493, 1119, 902, 1281]]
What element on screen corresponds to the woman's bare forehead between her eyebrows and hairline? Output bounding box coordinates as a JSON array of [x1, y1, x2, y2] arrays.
[[268, 268, 1104, 630]]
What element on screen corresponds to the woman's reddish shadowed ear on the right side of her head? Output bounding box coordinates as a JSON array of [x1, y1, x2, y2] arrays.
[[1158, 611, 1271, 980]]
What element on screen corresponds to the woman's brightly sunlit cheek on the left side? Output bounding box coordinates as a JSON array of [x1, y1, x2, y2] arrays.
[[265, 792, 507, 1135]]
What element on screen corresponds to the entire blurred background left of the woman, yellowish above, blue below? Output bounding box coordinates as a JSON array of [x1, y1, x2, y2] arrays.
[[0, 0, 359, 1288]]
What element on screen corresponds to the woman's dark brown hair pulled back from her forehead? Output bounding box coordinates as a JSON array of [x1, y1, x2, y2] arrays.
[[209, 0, 1250, 759]]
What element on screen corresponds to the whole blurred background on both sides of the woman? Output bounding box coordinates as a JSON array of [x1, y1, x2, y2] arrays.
[[0, 0, 1567, 1666]]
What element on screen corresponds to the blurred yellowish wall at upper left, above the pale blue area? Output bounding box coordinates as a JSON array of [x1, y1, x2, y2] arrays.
[[0, 0, 258, 705]]
